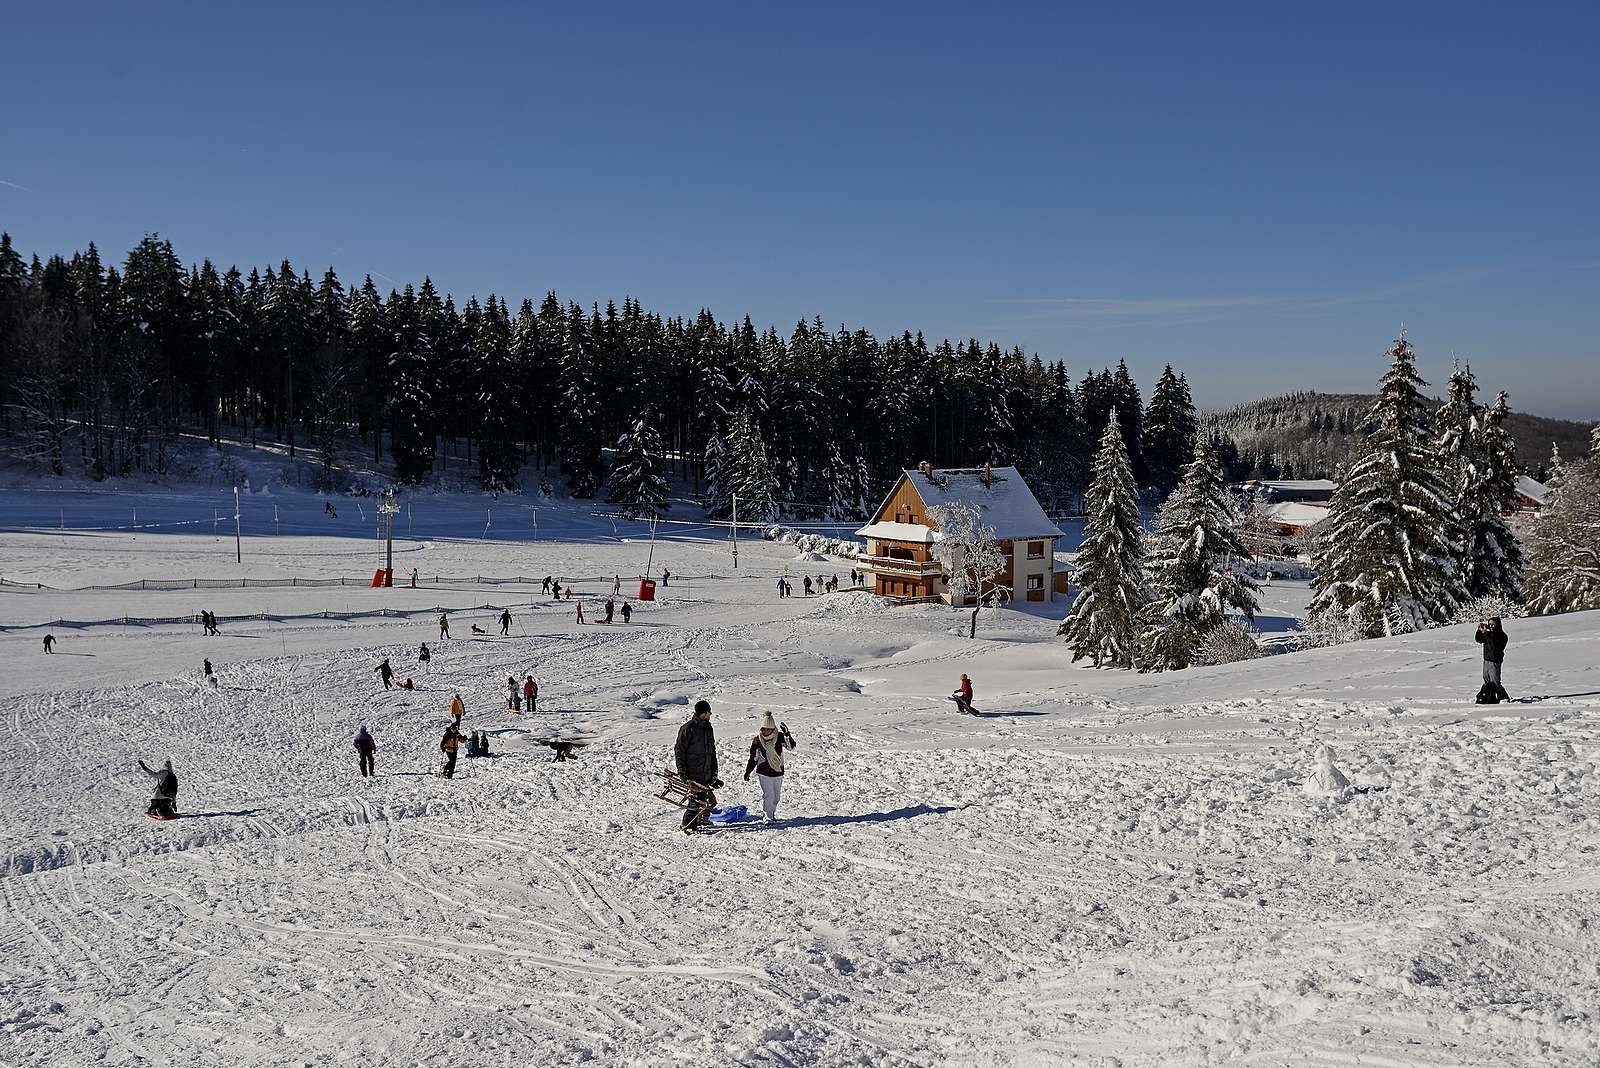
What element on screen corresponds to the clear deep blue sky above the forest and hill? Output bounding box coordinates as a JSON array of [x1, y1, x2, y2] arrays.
[[0, 0, 1600, 417]]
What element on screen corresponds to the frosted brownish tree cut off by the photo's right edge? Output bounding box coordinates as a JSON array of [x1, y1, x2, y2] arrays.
[[1528, 425, 1600, 614]]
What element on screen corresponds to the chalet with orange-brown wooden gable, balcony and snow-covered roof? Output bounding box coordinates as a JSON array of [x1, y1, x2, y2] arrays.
[[856, 464, 1067, 603]]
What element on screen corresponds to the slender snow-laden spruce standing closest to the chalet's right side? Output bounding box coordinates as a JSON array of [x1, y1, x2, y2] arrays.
[[1056, 409, 1144, 668]]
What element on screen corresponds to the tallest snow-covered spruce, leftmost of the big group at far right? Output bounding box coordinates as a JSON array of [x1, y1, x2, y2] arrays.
[[1310, 331, 1467, 638]]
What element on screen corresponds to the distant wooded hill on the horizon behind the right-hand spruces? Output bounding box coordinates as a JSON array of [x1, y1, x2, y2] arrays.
[[1200, 392, 1589, 478]]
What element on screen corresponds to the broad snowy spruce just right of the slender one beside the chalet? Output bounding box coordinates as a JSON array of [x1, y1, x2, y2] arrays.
[[1136, 441, 1261, 671]]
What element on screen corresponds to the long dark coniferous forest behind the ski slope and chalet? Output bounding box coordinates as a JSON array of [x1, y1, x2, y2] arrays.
[[0, 233, 1197, 520]]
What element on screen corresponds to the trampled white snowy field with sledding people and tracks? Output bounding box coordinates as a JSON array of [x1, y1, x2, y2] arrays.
[[0, 492, 1600, 1068]]
